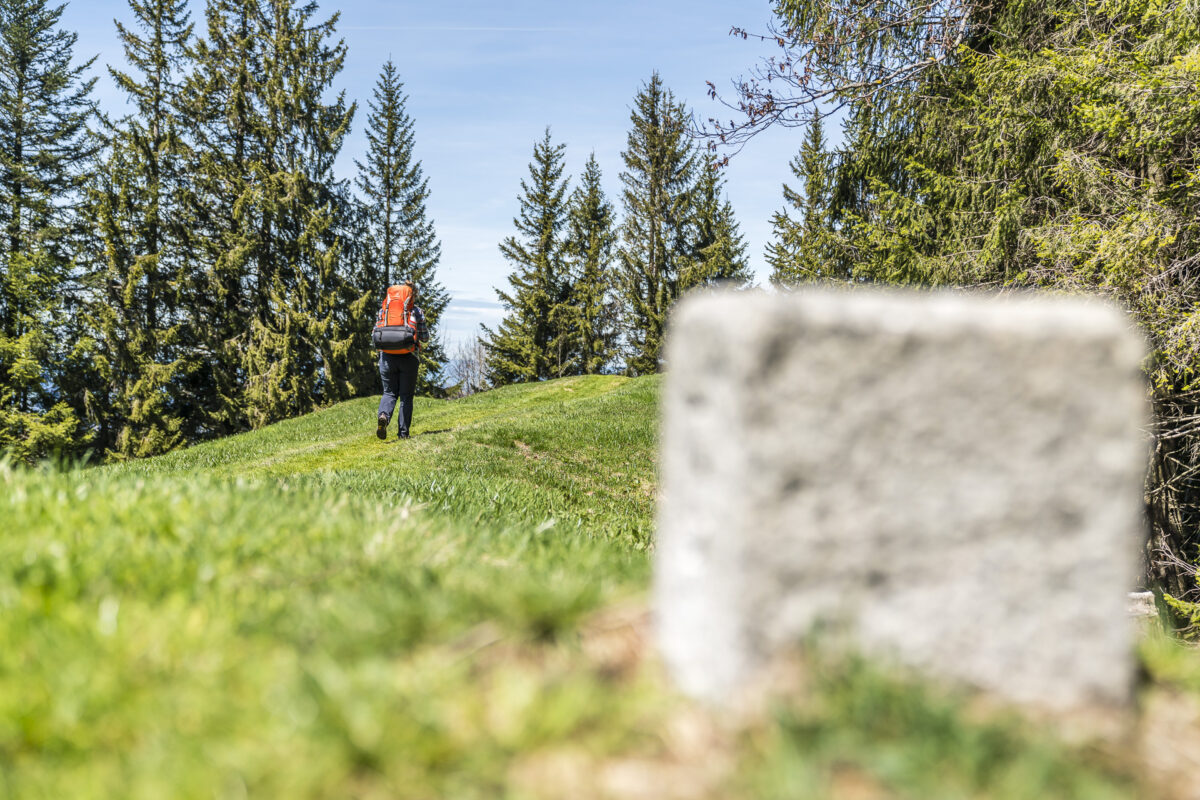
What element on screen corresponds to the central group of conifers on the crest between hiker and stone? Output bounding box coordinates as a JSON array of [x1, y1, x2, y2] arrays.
[[477, 73, 752, 385]]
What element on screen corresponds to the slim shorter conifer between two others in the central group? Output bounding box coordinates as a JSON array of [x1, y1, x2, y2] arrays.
[[566, 154, 619, 375]]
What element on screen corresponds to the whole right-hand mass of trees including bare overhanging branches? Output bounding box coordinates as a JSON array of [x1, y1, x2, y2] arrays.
[[739, 0, 1200, 594]]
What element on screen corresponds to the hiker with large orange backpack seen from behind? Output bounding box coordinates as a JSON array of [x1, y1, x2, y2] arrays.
[[371, 281, 430, 439]]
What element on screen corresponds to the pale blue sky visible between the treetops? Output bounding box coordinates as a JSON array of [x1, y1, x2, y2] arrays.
[[62, 0, 803, 354]]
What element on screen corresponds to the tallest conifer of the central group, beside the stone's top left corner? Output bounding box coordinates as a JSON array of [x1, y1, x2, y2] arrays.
[[619, 72, 696, 374]]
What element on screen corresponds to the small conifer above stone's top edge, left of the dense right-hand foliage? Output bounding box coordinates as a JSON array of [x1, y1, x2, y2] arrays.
[[767, 118, 848, 287]]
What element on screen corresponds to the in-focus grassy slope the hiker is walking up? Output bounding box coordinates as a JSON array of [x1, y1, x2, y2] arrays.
[[113, 377, 658, 549]]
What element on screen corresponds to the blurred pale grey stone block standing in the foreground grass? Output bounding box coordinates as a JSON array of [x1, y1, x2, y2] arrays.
[[654, 290, 1148, 710]]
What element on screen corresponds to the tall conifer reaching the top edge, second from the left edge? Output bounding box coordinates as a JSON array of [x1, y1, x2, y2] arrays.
[[85, 0, 194, 457]]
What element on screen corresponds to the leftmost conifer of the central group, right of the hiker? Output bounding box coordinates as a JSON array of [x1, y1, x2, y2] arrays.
[[484, 127, 576, 385]]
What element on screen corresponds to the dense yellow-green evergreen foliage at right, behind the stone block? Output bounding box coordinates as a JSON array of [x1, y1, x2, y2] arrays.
[[830, 0, 1200, 593]]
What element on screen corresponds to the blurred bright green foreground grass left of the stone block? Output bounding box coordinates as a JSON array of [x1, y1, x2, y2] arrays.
[[0, 473, 662, 798]]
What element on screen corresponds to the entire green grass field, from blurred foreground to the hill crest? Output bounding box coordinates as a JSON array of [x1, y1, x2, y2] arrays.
[[0, 377, 1200, 800]]
